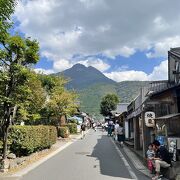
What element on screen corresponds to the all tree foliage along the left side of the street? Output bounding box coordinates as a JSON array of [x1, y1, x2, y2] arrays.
[[0, 0, 77, 159]]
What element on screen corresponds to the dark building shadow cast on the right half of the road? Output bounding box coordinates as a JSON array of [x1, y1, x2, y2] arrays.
[[87, 135, 131, 178]]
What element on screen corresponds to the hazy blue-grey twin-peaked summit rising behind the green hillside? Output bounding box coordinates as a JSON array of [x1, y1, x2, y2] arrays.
[[57, 64, 116, 90]]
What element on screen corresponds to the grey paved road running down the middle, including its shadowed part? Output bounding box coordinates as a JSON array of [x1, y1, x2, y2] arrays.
[[21, 130, 148, 180]]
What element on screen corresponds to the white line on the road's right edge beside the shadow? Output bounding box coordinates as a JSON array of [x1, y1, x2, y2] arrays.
[[111, 139, 138, 180]]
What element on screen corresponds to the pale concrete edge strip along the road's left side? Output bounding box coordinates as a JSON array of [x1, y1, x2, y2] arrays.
[[0, 129, 90, 180]]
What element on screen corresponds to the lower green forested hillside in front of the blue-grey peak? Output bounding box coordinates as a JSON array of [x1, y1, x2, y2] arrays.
[[78, 81, 149, 118]]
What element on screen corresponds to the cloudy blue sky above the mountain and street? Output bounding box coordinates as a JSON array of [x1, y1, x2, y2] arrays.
[[14, 0, 180, 82]]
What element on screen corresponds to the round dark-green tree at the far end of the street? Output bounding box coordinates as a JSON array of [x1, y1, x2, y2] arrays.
[[100, 94, 119, 116]]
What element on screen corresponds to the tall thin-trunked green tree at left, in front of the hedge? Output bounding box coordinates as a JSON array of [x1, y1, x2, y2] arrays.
[[0, 33, 39, 159]]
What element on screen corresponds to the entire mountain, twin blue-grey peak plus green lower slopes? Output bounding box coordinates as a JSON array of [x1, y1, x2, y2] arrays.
[[56, 64, 149, 118]]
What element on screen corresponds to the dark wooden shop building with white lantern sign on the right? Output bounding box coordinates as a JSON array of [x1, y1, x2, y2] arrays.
[[125, 48, 180, 160]]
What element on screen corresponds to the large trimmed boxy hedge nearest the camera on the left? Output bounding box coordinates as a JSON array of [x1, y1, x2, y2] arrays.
[[1, 125, 57, 156]]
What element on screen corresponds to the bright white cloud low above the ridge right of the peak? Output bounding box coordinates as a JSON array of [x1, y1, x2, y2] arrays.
[[104, 60, 168, 82]]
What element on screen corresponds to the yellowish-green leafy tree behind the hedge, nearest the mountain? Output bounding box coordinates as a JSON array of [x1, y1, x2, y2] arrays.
[[41, 75, 77, 124]]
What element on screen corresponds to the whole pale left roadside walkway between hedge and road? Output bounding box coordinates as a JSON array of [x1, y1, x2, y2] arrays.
[[0, 130, 89, 180]]
